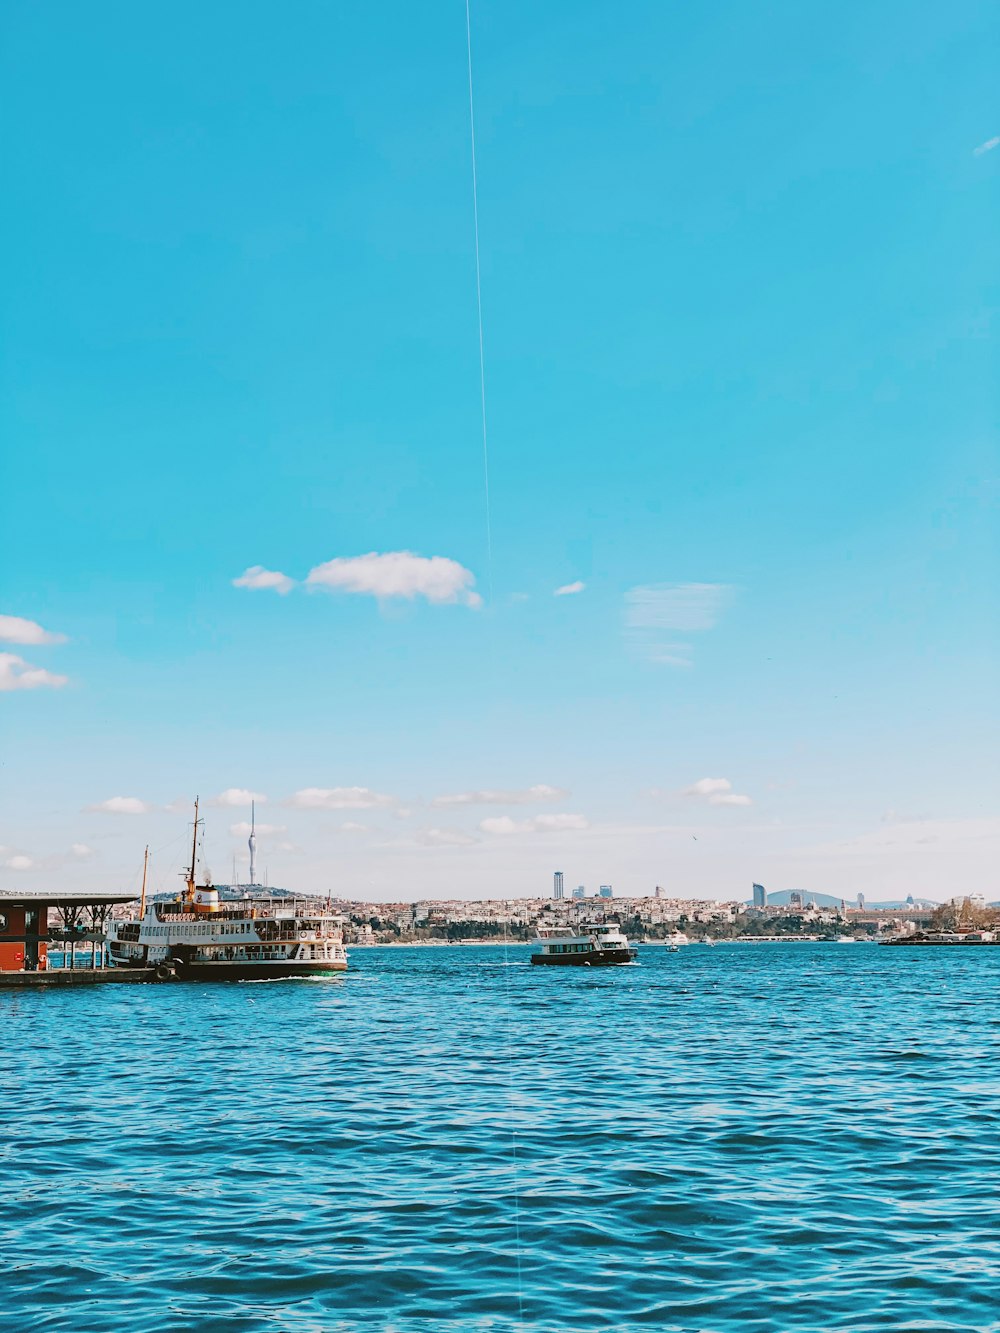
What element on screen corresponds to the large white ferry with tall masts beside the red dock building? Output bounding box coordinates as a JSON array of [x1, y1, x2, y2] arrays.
[[105, 801, 347, 981]]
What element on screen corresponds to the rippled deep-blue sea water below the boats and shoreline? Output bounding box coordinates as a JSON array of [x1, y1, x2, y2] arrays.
[[0, 944, 1000, 1333]]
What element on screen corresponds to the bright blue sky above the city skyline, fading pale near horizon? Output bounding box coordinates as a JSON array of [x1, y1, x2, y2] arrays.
[[0, 0, 1000, 898]]
